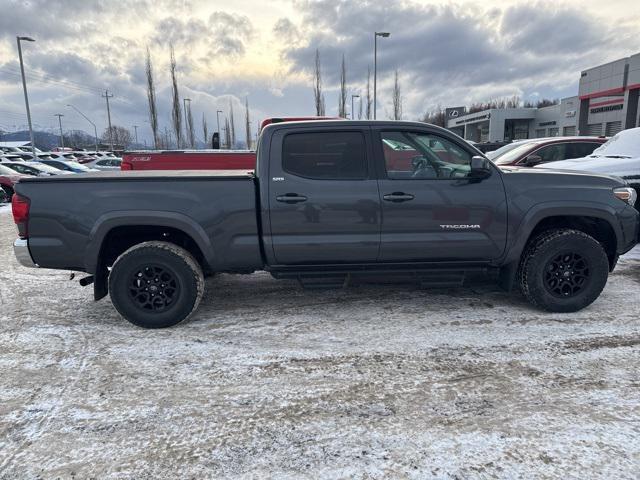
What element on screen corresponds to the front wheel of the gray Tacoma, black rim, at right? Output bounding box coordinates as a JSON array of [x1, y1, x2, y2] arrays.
[[518, 229, 609, 312]]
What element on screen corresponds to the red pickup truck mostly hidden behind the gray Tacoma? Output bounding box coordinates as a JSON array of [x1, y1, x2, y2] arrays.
[[120, 117, 338, 170]]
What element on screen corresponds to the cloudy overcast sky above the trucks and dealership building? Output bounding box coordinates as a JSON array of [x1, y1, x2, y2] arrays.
[[0, 0, 640, 142]]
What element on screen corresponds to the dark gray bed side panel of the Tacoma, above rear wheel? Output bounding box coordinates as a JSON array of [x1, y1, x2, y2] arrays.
[[16, 170, 262, 273]]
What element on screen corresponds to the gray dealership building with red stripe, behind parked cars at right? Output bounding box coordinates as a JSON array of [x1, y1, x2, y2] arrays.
[[446, 53, 640, 142]]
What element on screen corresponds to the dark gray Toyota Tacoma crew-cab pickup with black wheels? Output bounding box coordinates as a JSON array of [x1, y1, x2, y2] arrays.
[[14, 121, 639, 328]]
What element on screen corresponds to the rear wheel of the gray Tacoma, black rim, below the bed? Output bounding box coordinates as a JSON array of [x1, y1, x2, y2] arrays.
[[109, 241, 204, 328]]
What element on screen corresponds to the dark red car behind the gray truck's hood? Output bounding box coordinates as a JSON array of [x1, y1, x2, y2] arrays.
[[492, 137, 607, 167]]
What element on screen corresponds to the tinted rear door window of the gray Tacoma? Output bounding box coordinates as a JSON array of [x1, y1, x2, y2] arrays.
[[282, 132, 367, 180]]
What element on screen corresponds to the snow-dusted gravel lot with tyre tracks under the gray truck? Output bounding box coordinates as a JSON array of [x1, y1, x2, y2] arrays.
[[0, 207, 640, 480]]
